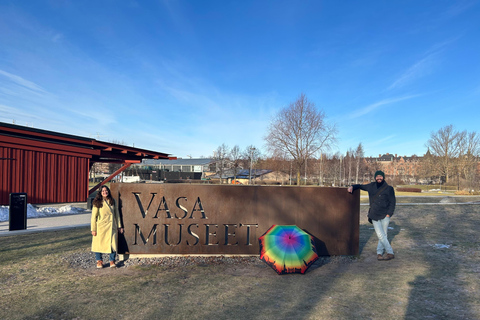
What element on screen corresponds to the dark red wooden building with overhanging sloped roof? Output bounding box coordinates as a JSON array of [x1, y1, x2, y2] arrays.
[[0, 122, 175, 205]]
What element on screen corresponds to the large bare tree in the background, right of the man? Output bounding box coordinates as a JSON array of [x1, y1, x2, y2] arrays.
[[426, 125, 466, 183]]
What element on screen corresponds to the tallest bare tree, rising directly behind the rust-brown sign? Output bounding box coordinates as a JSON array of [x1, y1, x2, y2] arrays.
[[265, 93, 337, 184]]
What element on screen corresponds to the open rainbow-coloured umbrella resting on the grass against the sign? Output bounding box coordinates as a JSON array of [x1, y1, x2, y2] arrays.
[[258, 225, 318, 274]]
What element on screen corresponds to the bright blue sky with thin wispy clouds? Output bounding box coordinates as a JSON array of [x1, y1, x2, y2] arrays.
[[0, 0, 480, 157]]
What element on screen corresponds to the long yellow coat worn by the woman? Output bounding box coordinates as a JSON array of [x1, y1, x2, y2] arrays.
[[91, 200, 122, 253]]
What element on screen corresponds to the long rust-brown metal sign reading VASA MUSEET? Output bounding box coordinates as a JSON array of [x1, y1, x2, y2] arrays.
[[111, 183, 360, 255]]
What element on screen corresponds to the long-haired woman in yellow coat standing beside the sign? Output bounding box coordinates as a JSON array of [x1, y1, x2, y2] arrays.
[[91, 186, 123, 269]]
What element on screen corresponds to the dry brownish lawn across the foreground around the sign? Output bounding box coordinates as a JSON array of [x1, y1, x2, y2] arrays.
[[0, 204, 480, 319]]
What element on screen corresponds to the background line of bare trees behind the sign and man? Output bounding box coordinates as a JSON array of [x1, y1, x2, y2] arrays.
[[213, 125, 480, 190]]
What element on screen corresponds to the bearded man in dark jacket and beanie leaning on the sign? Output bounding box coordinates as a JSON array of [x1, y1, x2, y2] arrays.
[[348, 171, 395, 261]]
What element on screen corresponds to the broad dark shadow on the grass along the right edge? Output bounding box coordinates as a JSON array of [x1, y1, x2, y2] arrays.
[[404, 205, 480, 319]]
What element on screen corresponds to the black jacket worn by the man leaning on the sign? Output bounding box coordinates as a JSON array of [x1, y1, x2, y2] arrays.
[[352, 182, 396, 220]]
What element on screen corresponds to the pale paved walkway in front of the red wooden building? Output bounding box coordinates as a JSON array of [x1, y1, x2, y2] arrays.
[[0, 211, 92, 237]]
